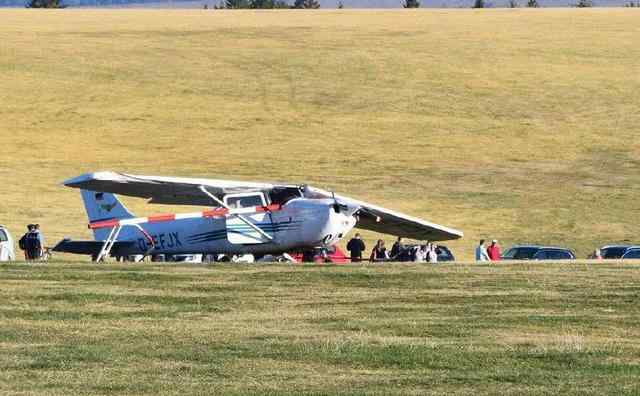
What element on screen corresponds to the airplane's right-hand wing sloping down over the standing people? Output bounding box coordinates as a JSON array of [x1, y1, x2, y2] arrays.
[[307, 187, 463, 241]]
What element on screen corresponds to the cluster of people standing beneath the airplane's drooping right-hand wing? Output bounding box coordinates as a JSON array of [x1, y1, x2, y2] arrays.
[[347, 233, 438, 263]]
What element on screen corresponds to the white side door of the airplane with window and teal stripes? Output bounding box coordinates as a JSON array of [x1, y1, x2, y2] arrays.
[[224, 193, 274, 245]]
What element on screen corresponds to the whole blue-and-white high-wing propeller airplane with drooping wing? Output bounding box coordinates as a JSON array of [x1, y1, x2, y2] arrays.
[[54, 172, 462, 261]]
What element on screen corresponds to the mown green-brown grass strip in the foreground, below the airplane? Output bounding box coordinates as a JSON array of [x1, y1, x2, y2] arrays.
[[0, 263, 640, 395]]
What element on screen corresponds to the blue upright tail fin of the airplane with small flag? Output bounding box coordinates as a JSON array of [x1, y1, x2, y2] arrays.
[[80, 190, 135, 241]]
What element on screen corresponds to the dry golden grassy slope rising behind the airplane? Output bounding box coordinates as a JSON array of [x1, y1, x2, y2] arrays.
[[0, 9, 640, 259]]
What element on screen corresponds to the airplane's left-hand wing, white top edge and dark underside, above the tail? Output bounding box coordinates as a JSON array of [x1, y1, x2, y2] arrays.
[[64, 172, 282, 206]]
